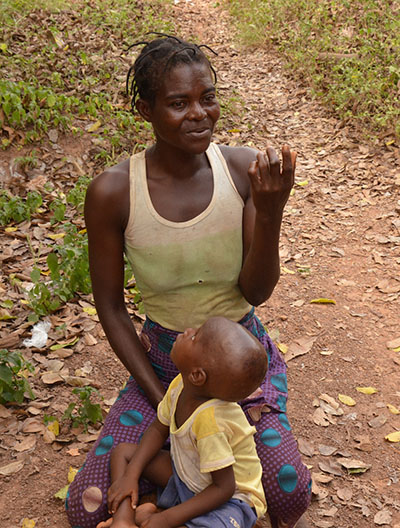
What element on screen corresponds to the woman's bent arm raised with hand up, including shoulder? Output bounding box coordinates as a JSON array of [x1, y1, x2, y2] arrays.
[[221, 146, 296, 306]]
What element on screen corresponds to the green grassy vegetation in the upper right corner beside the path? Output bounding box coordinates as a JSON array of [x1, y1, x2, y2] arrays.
[[227, 0, 400, 138]]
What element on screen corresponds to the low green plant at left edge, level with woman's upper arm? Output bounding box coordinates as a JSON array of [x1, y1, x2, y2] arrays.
[[0, 190, 43, 225]]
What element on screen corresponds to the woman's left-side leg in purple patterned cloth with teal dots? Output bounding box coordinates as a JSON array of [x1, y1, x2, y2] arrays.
[[65, 379, 156, 528]]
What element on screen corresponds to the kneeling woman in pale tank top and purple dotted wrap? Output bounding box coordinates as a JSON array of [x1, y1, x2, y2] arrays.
[[67, 37, 310, 528]]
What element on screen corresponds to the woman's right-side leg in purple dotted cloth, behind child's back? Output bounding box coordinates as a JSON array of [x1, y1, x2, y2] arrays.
[[241, 313, 311, 528]]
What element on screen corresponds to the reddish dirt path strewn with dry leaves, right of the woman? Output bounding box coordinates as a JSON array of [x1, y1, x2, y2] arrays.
[[172, 0, 400, 528]]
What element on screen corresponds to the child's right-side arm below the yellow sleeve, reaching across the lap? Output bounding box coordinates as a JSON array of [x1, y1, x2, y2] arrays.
[[142, 466, 236, 528]]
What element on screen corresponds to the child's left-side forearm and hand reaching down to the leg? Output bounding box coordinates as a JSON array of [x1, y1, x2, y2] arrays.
[[107, 418, 169, 513]]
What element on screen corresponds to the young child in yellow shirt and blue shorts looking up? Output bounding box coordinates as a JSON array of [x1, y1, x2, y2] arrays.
[[98, 317, 268, 528]]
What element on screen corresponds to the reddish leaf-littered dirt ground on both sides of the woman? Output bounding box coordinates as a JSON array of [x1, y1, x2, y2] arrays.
[[0, 0, 400, 528]]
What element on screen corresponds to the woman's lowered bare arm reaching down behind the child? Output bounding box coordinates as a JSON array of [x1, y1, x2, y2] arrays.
[[85, 166, 165, 407]]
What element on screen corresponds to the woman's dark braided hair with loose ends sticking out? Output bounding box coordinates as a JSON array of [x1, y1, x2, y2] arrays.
[[126, 33, 217, 111]]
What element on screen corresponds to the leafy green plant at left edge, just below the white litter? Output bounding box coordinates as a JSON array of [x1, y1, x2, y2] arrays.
[[0, 349, 35, 403]]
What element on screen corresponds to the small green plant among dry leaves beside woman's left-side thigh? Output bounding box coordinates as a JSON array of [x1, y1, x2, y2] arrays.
[[61, 385, 103, 431]]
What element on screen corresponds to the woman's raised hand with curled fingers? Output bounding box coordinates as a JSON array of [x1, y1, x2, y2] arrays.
[[248, 145, 297, 220]]
